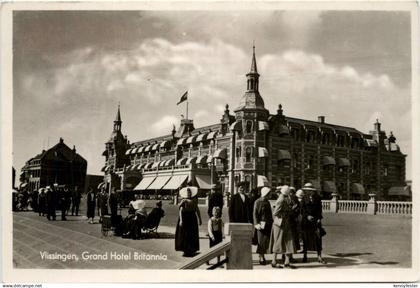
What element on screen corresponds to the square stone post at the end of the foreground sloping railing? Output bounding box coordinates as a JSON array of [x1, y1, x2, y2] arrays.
[[225, 223, 252, 270]]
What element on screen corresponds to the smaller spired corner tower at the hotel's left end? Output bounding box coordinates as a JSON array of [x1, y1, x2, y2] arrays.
[[102, 103, 130, 174]]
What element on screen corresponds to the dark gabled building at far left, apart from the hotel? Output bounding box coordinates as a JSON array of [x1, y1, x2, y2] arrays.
[[20, 138, 87, 191]]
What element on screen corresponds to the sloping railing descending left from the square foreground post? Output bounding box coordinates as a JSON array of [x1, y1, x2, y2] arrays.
[[179, 236, 231, 270]]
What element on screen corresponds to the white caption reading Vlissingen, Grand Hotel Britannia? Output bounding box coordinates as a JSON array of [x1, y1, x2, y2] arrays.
[[39, 251, 168, 262]]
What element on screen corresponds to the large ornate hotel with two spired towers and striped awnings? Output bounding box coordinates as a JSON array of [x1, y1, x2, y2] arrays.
[[103, 48, 406, 199]]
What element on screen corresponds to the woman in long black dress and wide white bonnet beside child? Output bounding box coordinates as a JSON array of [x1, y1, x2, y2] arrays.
[[175, 187, 201, 257]]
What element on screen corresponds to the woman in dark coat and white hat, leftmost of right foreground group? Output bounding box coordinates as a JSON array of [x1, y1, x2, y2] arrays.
[[253, 187, 273, 265]]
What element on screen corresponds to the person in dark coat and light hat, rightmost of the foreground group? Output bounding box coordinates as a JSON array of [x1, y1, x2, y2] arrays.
[[302, 183, 325, 264]]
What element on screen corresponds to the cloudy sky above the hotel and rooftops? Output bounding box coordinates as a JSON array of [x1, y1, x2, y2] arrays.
[[13, 10, 412, 179]]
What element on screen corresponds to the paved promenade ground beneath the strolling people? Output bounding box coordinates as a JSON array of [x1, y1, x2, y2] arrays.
[[13, 201, 411, 269]]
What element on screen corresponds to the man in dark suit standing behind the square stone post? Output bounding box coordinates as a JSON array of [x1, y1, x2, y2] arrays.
[[229, 182, 253, 224]]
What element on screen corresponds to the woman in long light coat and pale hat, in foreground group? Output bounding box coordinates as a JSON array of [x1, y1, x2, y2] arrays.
[[270, 185, 296, 268]]
